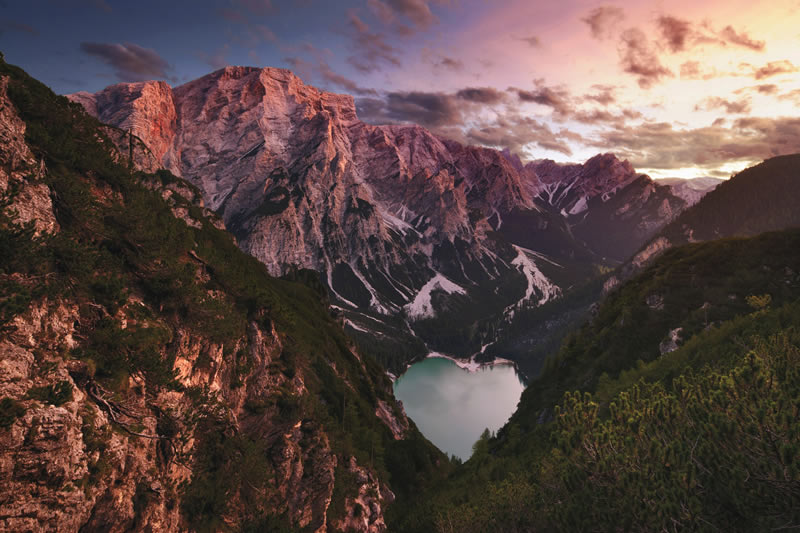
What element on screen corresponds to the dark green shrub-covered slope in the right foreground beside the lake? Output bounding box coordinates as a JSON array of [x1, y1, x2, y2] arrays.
[[399, 225, 800, 532]]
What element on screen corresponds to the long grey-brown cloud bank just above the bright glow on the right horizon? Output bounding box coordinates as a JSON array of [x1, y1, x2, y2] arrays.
[[586, 117, 800, 169]]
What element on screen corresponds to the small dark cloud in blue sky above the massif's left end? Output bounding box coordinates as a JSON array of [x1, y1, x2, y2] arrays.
[[80, 42, 171, 81]]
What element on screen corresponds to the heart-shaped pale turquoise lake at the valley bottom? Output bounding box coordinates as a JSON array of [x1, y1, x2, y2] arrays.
[[394, 357, 525, 461]]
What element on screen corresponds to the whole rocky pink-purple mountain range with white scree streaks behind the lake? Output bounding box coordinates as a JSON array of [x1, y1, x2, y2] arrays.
[[70, 67, 708, 370]]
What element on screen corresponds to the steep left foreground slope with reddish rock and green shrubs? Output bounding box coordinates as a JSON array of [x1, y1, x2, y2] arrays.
[[0, 58, 449, 532]]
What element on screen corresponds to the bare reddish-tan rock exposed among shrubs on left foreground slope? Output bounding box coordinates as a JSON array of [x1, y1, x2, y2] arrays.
[[0, 68, 408, 532]]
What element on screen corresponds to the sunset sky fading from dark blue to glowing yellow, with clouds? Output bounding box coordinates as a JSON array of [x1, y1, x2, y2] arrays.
[[0, 0, 800, 178]]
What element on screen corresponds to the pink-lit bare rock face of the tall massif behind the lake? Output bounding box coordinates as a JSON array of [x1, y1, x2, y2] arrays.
[[71, 67, 535, 298]]
